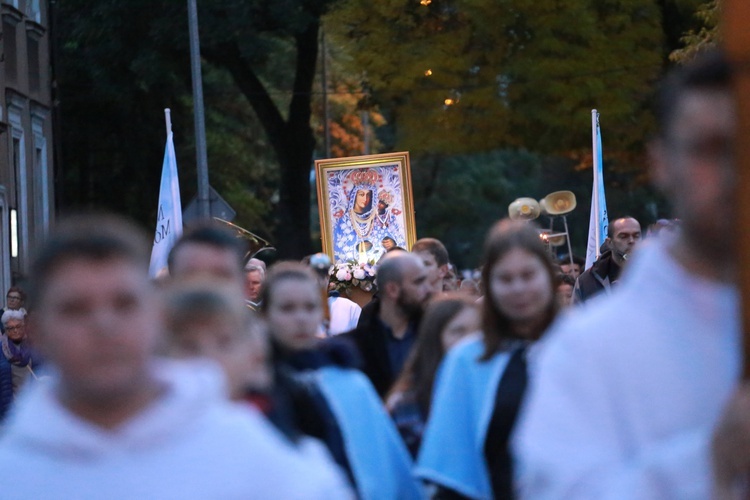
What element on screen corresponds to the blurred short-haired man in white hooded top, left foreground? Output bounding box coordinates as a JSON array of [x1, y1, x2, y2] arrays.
[[0, 216, 346, 499]]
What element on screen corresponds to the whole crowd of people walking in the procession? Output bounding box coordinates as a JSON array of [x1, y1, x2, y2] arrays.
[[0, 48, 750, 499]]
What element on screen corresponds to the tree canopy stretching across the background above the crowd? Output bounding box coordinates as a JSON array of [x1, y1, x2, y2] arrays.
[[53, 0, 713, 266]]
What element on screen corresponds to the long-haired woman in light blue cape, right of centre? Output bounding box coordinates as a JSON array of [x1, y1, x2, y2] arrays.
[[417, 219, 558, 499]]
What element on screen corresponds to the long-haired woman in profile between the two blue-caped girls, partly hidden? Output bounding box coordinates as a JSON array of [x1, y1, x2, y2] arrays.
[[386, 292, 480, 457]]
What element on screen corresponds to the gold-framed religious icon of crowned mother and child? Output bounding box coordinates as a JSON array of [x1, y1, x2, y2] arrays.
[[315, 152, 416, 263]]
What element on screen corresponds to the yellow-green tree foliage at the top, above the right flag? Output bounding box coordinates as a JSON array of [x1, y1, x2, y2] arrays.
[[326, 0, 662, 153]]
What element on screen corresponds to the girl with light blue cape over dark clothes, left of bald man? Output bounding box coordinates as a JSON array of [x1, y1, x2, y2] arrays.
[[261, 262, 423, 499]]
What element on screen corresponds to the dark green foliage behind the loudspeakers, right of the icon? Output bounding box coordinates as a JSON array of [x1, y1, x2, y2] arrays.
[[413, 150, 667, 269]]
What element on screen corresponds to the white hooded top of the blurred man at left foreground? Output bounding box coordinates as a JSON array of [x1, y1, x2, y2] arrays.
[[0, 360, 350, 500]]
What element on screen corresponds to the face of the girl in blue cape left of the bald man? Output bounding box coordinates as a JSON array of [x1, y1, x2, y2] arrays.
[[265, 278, 323, 351]]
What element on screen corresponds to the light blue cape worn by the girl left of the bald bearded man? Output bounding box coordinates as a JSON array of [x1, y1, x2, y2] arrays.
[[317, 366, 425, 500]]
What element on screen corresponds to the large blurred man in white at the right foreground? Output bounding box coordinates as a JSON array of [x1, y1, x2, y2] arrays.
[[514, 52, 750, 499]]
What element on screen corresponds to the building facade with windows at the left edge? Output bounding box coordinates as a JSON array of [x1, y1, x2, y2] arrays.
[[0, 0, 54, 297]]
